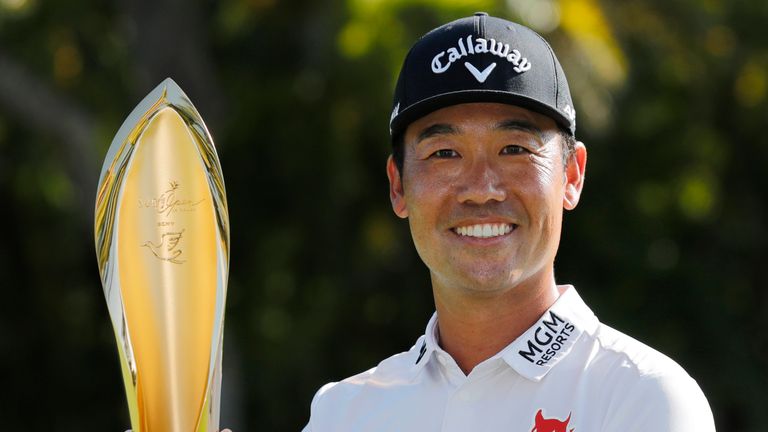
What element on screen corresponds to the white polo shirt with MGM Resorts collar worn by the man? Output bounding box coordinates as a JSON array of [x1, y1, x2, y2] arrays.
[[304, 287, 715, 432]]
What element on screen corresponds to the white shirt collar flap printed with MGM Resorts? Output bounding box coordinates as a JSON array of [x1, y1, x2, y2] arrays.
[[499, 286, 598, 381]]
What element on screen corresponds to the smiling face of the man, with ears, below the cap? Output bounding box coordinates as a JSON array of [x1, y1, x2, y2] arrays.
[[387, 103, 586, 294]]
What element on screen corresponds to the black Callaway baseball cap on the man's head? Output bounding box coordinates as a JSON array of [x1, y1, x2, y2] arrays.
[[389, 12, 576, 137]]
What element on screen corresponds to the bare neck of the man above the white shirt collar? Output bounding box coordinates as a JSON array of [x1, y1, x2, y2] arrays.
[[433, 277, 560, 374]]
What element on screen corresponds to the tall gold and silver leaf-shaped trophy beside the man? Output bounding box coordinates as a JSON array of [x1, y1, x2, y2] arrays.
[[95, 78, 229, 432]]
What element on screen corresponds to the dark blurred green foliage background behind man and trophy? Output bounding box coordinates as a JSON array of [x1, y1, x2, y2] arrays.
[[0, 0, 768, 432]]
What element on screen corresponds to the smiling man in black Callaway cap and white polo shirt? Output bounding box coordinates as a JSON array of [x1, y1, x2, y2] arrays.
[[305, 13, 714, 432]]
